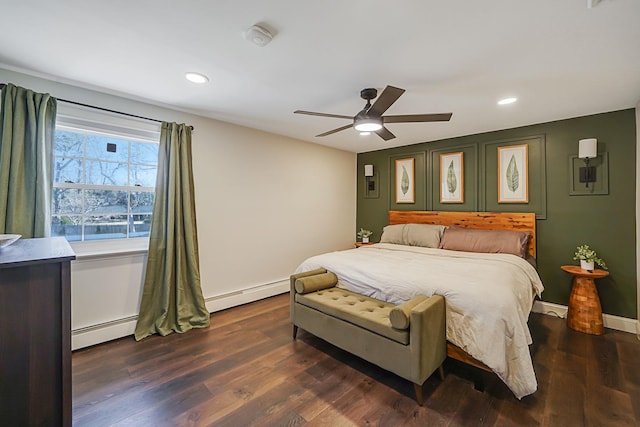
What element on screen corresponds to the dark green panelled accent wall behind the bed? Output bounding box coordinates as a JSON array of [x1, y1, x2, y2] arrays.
[[356, 109, 637, 319]]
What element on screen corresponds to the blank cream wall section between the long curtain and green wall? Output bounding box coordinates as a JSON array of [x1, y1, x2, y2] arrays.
[[194, 113, 356, 296]]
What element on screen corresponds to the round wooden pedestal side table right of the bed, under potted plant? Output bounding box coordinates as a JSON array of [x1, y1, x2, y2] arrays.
[[560, 265, 609, 335]]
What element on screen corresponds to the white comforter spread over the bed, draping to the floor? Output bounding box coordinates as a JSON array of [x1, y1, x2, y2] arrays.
[[296, 243, 544, 399]]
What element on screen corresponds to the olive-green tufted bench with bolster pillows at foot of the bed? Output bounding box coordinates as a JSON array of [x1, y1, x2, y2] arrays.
[[291, 269, 446, 405]]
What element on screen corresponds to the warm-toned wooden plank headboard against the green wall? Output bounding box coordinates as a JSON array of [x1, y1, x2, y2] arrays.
[[389, 211, 536, 258]]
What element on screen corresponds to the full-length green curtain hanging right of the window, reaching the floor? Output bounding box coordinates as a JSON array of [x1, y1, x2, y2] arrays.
[[135, 123, 209, 341]]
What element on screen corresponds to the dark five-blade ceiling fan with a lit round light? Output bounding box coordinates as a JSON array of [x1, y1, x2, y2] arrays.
[[294, 86, 453, 141]]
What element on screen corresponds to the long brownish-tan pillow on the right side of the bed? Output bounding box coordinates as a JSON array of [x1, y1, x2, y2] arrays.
[[440, 227, 530, 258]]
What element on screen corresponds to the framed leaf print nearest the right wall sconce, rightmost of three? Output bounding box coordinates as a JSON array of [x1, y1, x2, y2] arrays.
[[498, 144, 529, 203]]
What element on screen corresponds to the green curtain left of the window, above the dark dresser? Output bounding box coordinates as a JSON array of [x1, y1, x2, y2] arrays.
[[0, 84, 57, 238]]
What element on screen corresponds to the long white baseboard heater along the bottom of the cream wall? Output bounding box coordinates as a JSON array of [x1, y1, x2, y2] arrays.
[[71, 279, 289, 350]]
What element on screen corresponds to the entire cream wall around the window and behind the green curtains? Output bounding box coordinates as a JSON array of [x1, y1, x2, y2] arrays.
[[0, 69, 356, 348]]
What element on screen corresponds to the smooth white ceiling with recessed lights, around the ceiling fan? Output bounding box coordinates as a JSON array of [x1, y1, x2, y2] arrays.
[[0, 0, 640, 152]]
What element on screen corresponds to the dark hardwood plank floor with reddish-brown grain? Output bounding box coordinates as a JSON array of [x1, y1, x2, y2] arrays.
[[73, 295, 640, 427]]
